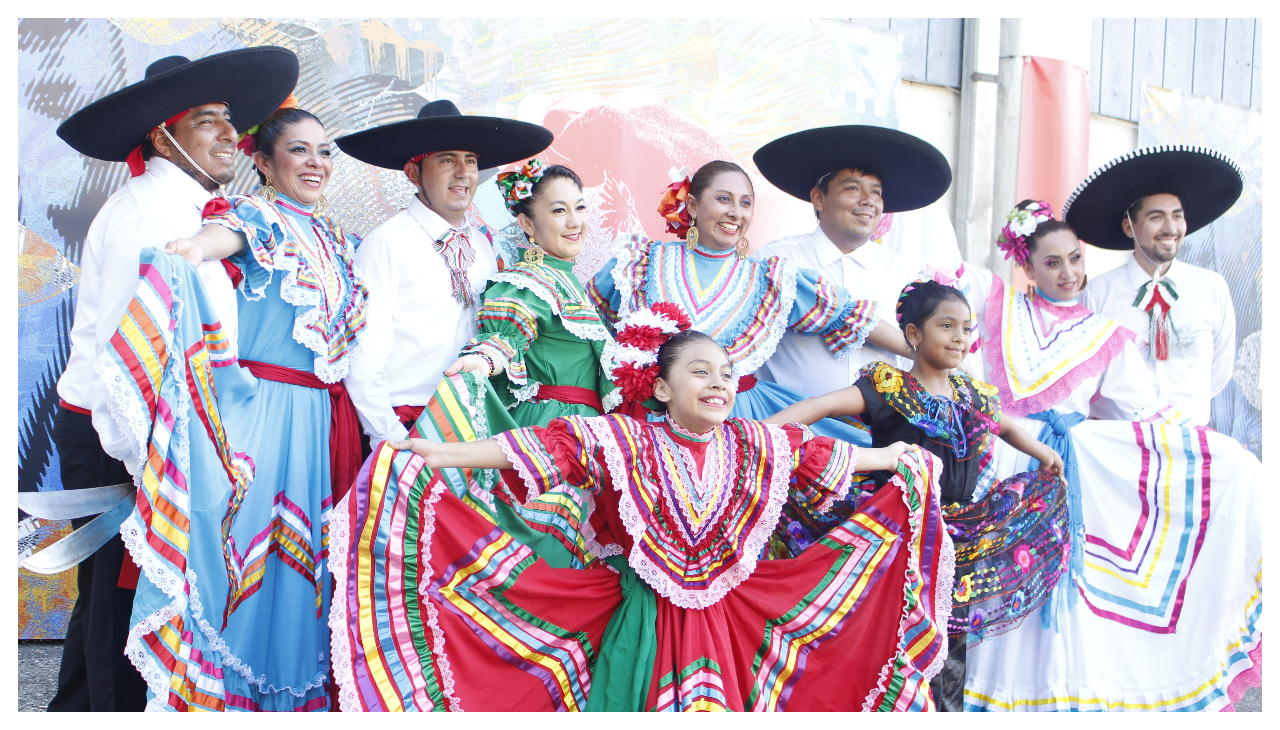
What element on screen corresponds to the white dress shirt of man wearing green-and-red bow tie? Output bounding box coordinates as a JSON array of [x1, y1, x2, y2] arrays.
[[1082, 257, 1235, 425]]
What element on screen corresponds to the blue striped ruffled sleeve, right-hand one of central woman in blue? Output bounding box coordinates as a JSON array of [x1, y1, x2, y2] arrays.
[[787, 266, 879, 360]]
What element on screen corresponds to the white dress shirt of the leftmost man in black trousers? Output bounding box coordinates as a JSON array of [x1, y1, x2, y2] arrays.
[[58, 158, 237, 474]]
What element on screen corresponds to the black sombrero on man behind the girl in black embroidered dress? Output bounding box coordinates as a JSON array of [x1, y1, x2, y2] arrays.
[[753, 124, 951, 213]]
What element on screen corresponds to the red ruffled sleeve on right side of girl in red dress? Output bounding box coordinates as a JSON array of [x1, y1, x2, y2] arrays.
[[782, 424, 865, 512]]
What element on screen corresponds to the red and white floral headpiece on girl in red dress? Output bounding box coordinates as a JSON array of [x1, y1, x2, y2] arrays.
[[604, 302, 692, 403]]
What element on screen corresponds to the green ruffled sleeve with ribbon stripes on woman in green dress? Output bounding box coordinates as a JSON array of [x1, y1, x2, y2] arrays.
[[462, 282, 552, 385]]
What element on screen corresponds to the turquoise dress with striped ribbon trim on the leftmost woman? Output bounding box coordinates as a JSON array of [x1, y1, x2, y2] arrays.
[[120, 195, 367, 711]]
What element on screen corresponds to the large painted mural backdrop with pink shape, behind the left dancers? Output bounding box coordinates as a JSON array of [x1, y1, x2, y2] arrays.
[[18, 19, 902, 638]]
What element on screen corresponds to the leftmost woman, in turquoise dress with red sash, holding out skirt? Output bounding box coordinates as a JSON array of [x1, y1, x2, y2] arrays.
[[100, 109, 367, 711]]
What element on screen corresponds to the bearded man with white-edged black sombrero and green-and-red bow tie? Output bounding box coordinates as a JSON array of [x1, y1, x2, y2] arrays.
[[1062, 147, 1244, 425]]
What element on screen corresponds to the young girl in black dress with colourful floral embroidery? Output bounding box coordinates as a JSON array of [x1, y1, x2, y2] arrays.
[[767, 275, 1068, 712]]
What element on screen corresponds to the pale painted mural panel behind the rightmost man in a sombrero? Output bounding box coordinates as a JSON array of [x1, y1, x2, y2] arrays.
[[1138, 86, 1262, 458]]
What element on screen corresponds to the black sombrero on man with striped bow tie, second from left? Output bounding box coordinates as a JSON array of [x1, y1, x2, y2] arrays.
[[334, 99, 553, 170]]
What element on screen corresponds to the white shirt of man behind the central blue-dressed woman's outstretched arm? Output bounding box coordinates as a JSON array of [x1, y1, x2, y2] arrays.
[[756, 227, 919, 396]]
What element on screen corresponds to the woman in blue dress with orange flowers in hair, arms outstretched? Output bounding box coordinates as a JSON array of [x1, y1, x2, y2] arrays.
[[588, 160, 911, 446]]
